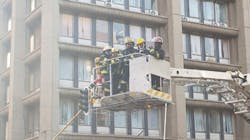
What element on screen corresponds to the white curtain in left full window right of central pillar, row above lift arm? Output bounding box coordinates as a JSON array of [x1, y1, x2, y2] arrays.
[[190, 35, 201, 56]]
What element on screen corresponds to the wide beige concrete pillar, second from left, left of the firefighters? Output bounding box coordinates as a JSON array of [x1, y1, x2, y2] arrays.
[[40, 0, 60, 140]]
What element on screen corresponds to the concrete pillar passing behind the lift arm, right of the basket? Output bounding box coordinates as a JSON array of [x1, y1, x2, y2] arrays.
[[166, 0, 186, 140]]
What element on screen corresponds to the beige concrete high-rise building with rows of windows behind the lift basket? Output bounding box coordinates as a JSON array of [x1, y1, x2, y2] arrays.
[[0, 0, 250, 140]]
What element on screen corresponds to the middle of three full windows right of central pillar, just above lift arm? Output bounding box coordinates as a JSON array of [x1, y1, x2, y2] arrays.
[[204, 37, 216, 62]]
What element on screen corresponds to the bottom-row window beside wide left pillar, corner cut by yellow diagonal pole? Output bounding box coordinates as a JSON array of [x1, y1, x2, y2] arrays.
[[60, 98, 75, 125]]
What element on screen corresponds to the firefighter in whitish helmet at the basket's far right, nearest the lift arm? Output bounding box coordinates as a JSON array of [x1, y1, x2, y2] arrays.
[[149, 36, 165, 59]]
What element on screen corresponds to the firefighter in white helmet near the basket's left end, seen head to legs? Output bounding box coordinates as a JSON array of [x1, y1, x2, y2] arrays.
[[100, 46, 111, 96]]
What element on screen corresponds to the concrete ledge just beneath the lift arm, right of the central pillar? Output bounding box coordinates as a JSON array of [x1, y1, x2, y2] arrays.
[[186, 99, 232, 110]]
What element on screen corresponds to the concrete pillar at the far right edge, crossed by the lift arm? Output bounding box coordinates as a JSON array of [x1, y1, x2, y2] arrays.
[[235, 0, 250, 140]]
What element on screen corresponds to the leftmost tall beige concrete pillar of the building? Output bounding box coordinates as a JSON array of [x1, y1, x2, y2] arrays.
[[8, 0, 25, 140]]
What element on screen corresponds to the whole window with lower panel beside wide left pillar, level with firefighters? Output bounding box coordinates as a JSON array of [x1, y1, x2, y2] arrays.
[[60, 55, 74, 87]]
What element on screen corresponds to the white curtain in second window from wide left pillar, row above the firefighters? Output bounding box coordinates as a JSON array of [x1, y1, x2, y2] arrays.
[[78, 17, 92, 40]]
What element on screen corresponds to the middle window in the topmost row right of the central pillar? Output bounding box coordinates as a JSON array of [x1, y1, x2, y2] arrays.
[[203, 0, 214, 24]]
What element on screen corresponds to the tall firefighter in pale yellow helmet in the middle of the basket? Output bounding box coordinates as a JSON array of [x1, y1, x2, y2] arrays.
[[119, 37, 138, 92]]
